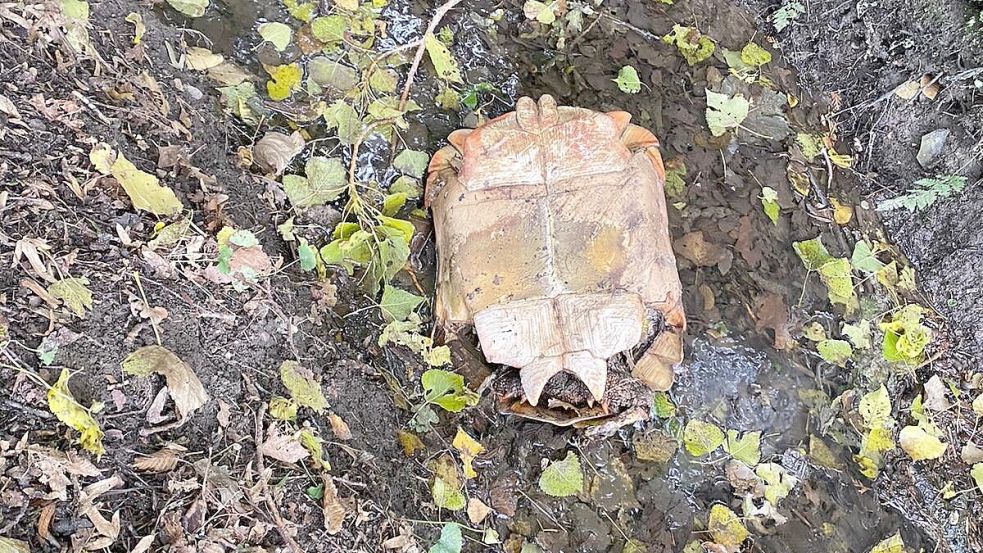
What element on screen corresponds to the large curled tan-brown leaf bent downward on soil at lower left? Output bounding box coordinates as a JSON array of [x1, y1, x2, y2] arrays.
[[122, 346, 208, 424]]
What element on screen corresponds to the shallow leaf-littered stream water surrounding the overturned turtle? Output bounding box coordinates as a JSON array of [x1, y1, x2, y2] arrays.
[[171, 0, 936, 553]]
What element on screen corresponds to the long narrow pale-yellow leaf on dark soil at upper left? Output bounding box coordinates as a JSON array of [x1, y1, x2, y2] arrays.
[[89, 142, 184, 216]]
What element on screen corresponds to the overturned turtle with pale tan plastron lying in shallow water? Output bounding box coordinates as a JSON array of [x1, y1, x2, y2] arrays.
[[424, 95, 686, 424]]
